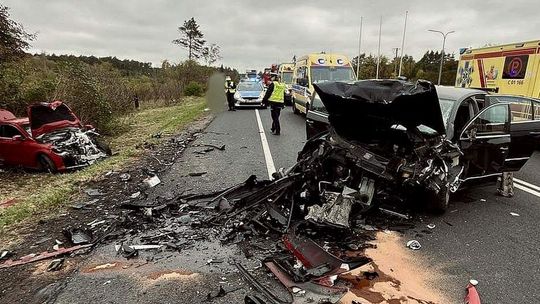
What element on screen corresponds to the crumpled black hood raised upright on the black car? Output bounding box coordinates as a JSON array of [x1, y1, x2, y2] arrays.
[[313, 80, 445, 139]]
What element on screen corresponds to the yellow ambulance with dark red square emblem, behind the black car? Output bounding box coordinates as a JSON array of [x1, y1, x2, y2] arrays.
[[456, 40, 540, 98]]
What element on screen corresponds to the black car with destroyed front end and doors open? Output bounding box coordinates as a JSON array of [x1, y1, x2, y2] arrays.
[[299, 80, 540, 211]]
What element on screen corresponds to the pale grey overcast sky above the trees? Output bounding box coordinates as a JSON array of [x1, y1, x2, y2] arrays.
[[2, 0, 540, 71]]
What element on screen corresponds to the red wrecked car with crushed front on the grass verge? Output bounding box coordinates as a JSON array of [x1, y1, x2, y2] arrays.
[[0, 101, 111, 172]]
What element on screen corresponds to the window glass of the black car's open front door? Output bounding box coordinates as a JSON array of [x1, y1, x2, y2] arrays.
[[463, 104, 508, 138]]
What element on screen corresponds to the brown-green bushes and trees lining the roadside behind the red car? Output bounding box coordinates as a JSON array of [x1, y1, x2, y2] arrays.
[[0, 5, 238, 133]]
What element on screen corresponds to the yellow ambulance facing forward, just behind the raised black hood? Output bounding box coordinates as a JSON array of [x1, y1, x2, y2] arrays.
[[292, 53, 356, 114]]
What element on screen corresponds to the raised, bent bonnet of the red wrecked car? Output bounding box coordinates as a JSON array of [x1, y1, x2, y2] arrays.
[[28, 101, 82, 137]]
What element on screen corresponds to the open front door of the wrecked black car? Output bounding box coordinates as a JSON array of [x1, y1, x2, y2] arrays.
[[459, 103, 511, 177]]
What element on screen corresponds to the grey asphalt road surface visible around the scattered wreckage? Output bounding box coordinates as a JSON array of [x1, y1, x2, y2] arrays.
[[48, 108, 540, 304]]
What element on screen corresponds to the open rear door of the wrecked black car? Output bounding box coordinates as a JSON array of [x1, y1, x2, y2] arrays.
[[489, 95, 540, 171]]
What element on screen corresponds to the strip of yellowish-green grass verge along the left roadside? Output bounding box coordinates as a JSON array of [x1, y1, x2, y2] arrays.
[[0, 98, 206, 230]]
